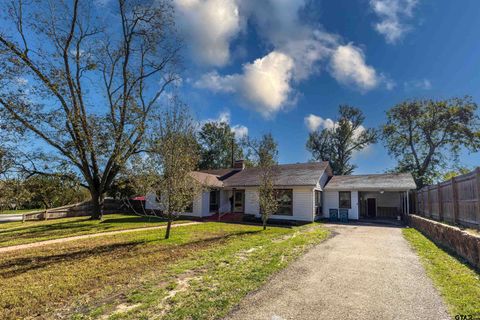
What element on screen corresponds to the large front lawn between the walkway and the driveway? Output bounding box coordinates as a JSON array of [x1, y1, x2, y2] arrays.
[[0, 222, 328, 320]]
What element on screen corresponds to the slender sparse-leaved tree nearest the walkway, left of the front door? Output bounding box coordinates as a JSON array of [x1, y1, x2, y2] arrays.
[[150, 101, 201, 239]]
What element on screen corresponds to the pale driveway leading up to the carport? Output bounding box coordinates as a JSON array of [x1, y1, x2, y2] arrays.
[[226, 224, 450, 320]]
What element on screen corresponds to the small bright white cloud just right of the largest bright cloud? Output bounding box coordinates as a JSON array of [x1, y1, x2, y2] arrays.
[[330, 44, 381, 90]]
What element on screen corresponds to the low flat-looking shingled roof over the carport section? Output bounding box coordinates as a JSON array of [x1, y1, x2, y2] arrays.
[[324, 173, 417, 191]]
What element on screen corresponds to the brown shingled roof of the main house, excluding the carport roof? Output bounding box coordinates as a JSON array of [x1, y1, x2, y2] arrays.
[[223, 162, 329, 187]]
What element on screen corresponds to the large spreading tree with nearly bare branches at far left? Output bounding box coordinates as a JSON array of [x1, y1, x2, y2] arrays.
[[0, 0, 179, 219]]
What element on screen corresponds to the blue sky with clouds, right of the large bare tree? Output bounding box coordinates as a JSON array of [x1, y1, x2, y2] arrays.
[[174, 0, 480, 173]]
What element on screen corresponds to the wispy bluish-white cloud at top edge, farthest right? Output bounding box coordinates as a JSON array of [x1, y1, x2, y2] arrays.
[[370, 0, 418, 43]]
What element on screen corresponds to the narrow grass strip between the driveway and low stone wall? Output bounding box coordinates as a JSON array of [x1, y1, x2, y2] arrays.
[[403, 228, 480, 318]]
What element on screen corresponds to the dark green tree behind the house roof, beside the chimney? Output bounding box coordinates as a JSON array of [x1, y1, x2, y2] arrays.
[[198, 121, 243, 169]]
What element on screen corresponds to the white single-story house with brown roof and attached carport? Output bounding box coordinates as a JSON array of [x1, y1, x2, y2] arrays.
[[147, 160, 416, 221]]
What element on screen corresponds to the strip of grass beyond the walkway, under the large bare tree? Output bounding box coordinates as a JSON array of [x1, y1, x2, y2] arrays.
[[0, 214, 188, 247]]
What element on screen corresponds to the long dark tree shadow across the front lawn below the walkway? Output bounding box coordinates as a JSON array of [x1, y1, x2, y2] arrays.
[[0, 230, 261, 278]]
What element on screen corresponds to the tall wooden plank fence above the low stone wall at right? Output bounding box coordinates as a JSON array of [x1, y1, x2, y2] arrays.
[[415, 167, 480, 229]]
